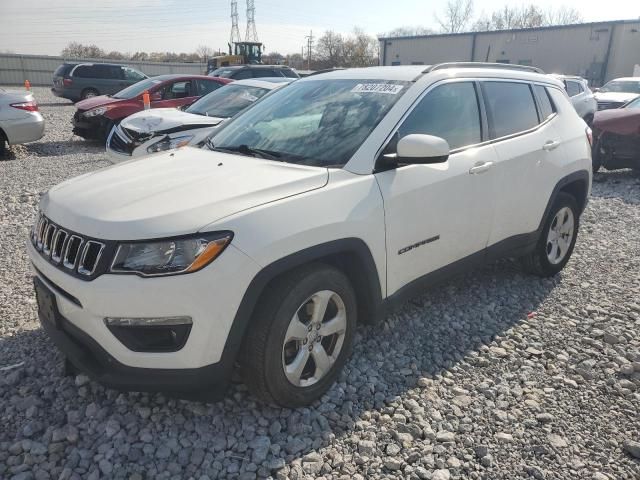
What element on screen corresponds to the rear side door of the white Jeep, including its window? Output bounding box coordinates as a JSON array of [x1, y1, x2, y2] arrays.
[[482, 80, 563, 245]]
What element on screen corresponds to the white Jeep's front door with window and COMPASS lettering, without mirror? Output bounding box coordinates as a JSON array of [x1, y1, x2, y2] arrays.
[[376, 81, 496, 295]]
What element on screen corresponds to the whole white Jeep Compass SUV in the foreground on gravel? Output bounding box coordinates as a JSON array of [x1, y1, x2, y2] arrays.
[[28, 64, 591, 407]]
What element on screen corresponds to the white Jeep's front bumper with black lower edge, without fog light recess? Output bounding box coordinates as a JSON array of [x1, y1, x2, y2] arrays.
[[27, 237, 259, 385]]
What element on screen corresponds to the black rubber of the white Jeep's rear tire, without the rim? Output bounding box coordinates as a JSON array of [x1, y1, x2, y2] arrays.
[[520, 192, 580, 277]]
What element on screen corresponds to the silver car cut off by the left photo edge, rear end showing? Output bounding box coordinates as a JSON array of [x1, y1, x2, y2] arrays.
[[0, 88, 44, 158]]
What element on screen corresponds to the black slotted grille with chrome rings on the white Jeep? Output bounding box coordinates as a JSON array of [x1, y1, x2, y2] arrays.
[[31, 215, 105, 277]]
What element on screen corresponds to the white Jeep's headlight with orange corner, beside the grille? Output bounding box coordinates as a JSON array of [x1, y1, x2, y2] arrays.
[[110, 232, 233, 277]]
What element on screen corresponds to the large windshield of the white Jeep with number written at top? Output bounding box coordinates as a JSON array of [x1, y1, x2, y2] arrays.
[[209, 80, 409, 167]]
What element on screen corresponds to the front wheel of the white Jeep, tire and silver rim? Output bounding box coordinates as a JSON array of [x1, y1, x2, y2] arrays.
[[240, 264, 357, 408]]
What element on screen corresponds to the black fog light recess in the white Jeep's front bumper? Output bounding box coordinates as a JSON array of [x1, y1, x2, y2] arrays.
[[104, 317, 193, 353]]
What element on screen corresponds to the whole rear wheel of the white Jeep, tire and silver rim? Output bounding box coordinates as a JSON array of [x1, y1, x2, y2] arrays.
[[521, 192, 580, 277]]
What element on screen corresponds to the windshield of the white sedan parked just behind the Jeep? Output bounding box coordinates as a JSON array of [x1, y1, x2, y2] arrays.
[[186, 84, 269, 118]]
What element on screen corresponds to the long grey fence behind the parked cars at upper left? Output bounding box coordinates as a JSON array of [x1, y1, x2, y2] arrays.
[[0, 53, 206, 85]]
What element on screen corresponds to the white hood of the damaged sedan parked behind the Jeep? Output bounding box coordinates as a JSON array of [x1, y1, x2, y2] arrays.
[[121, 108, 224, 133]]
